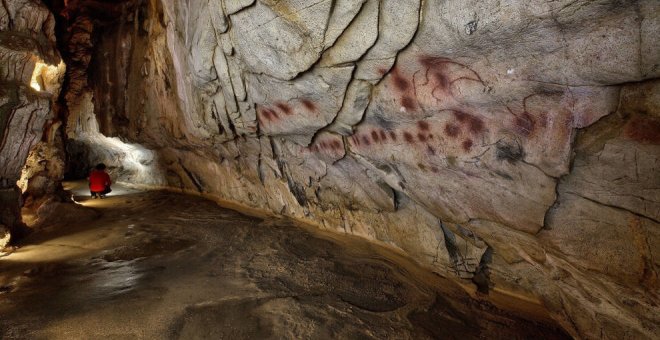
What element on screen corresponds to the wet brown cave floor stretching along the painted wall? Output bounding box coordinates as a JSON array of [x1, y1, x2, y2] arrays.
[[0, 182, 566, 339]]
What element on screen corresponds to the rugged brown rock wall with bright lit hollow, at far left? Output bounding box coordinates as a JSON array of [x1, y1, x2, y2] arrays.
[[0, 0, 64, 249]]
